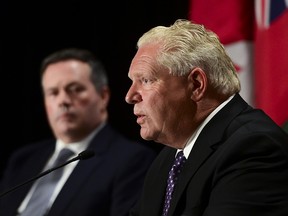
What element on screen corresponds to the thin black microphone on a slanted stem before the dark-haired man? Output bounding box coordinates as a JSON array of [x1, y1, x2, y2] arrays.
[[0, 150, 95, 198]]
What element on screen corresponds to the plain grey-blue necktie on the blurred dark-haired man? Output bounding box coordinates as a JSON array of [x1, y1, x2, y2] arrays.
[[21, 148, 73, 216]]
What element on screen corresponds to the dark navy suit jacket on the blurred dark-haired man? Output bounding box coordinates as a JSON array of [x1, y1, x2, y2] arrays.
[[0, 125, 156, 216]]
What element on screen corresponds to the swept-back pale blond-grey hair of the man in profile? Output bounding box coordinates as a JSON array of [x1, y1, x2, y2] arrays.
[[137, 19, 241, 95]]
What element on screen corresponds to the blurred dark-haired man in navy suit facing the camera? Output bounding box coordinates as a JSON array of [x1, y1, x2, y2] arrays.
[[0, 49, 156, 216]]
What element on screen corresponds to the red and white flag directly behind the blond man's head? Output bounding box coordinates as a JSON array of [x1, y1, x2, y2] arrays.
[[188, 0, 254, 105]]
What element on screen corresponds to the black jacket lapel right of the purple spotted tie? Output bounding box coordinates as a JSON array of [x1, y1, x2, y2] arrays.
[[169, 94, 250, 215]]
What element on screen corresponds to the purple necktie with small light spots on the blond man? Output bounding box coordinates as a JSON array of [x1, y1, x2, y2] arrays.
[[162, 151, 186, 216]]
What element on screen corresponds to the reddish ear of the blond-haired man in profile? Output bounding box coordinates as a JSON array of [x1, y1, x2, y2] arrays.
[[188, 67, 208, 102]]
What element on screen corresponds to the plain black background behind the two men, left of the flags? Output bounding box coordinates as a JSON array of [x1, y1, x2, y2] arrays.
[[0, 0, 188, 177]]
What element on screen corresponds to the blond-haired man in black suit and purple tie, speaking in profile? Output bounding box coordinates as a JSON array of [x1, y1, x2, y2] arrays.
[[126, 20, 288, 216]]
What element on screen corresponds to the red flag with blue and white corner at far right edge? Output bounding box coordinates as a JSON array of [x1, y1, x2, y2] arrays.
[[255, 0, 288, 126]]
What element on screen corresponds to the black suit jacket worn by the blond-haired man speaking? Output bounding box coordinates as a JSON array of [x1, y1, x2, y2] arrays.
[[131, 94, 288, 216]]
